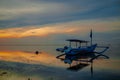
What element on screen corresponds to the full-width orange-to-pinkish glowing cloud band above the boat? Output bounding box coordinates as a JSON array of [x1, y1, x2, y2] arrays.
[[0, 20, 120, 38]]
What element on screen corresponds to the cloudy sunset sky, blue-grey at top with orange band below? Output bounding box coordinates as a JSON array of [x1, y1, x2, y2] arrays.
[[0, 0, 120, 44]]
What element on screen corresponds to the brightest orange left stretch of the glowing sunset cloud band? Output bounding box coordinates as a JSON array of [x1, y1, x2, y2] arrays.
[[0, 26, 77, 38]]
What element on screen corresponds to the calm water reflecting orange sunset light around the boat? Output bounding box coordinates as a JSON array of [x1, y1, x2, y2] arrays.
[[0, 45, 120, 80]]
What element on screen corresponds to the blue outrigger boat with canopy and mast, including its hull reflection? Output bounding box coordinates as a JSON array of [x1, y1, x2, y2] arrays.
[[56, 30, 109, 65]]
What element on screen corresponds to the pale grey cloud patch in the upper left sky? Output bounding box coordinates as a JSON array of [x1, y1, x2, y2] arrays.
[[0, 0, 70, 20]]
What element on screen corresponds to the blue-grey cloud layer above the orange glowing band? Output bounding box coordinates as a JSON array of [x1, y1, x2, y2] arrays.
[[0, 0, 120, 28]]
